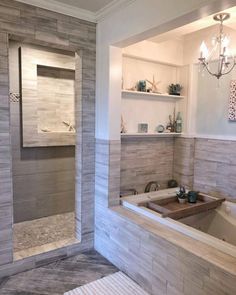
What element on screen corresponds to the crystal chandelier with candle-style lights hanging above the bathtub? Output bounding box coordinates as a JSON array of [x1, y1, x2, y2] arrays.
[[198, 13, 236, 79]]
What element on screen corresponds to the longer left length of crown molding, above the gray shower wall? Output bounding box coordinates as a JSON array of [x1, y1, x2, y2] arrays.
[[16, 0, 96, 23]]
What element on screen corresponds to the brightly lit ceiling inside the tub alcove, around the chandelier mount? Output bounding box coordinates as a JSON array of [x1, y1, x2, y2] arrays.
[[149, 6, 236, 43]]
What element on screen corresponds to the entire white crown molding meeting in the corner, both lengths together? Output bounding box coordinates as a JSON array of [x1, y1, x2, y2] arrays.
[[16, 0, 136, 23]]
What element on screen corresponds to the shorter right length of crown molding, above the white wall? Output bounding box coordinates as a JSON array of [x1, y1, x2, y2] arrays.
[[95, 0, 136, 22]]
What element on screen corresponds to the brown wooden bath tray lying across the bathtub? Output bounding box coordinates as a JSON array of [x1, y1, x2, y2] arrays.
[[146, 193, 225, 220]]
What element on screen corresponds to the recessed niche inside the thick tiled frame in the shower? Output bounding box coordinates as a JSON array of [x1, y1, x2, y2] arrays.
[[37, 65, 75, 133]]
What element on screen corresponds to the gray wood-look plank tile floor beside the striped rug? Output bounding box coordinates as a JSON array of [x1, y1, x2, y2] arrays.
[[0, 250, 118, 295]]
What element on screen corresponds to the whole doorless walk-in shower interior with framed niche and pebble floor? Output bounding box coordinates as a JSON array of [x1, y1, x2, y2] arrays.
[[9, 41, 76, 259]]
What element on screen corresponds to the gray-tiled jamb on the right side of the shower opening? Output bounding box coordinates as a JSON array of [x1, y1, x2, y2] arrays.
[[75, 50, 95, 239]]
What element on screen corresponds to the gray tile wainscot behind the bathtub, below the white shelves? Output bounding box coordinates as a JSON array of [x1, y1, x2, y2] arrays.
[[121, 137, 236, 199]]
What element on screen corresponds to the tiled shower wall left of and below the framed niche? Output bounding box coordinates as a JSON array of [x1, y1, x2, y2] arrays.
[[9, 41, 75, 223]]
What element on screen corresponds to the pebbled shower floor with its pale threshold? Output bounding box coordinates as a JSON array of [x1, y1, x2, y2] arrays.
[[13, 212, 76, 259]]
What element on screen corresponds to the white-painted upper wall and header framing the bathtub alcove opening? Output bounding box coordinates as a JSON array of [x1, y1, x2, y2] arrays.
[[96, 0, 235, 140]]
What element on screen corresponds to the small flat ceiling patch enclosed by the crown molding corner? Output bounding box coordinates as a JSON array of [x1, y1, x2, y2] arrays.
[[53, 0, 113, 12]]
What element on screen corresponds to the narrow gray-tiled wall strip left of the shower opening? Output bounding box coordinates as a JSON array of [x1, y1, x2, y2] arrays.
[[0, 33, 13, 265]]
